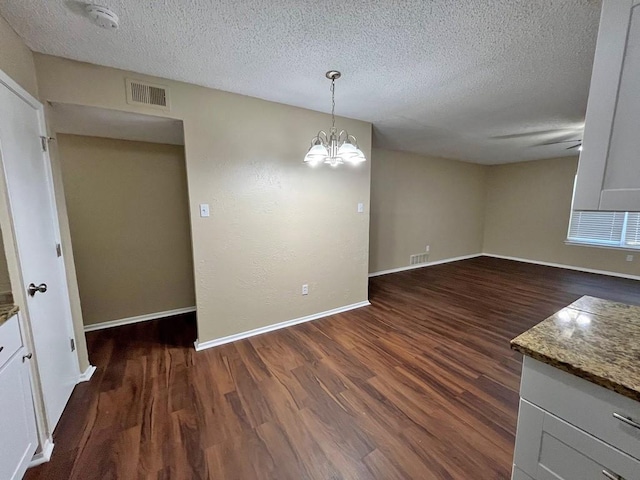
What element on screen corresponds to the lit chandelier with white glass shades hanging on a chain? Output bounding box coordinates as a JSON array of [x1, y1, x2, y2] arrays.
[[304, 70, 367, 167]]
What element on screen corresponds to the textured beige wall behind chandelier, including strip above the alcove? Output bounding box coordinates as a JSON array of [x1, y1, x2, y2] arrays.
[[36, 54, 371, 342]]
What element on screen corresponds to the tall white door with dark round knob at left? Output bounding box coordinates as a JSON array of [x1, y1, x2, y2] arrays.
[[0, 83, 79, 432]]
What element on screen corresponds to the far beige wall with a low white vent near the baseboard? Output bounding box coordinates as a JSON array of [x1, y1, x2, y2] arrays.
[[369, 149, 486, 272]]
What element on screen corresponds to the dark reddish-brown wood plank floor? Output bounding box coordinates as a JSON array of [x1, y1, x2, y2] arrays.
[[26, 257, 640, 480]]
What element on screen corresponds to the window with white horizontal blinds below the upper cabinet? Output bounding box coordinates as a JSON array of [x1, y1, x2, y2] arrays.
[[567, 211, 640, 249]]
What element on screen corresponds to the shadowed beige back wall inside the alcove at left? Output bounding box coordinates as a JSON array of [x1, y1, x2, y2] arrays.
[[57, 134, 195, 325]]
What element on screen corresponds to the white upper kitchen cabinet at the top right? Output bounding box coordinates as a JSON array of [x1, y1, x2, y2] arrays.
[[573, 0, 640, 212]]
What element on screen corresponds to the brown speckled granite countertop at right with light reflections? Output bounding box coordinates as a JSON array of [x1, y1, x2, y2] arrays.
[[511, 296, 640, 401]]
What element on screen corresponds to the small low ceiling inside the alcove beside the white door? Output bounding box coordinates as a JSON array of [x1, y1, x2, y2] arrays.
[[49, 103, 184, 145]]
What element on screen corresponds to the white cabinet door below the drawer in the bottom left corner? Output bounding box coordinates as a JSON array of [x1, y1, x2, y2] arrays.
[[0, 349, 38, 480]]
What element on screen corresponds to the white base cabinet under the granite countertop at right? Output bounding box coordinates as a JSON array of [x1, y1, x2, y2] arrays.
[[512, 357, 640, 480]]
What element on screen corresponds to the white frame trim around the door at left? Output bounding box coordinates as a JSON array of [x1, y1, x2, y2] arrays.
[[0, 70, 82, 466]]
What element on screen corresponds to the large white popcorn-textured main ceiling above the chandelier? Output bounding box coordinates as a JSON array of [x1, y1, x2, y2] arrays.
[[0, 0, 600, 164]]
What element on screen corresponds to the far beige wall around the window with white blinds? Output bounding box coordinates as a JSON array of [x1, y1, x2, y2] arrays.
[[484, 157, 640, 275]]
